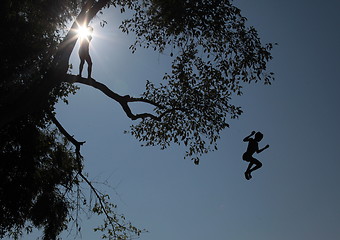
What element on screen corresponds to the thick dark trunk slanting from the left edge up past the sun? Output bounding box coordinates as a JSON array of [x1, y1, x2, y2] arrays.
[[0, 0, 110, 128]]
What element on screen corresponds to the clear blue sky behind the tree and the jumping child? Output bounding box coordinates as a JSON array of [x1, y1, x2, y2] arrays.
[[25, 0, 340, 240]]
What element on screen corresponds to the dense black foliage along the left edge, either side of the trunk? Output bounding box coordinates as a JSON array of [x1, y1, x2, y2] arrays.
[[0, 0, 77, 239]]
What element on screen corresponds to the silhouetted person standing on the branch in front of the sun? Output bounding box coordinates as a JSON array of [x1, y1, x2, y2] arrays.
[[78, 27, 93, 79]]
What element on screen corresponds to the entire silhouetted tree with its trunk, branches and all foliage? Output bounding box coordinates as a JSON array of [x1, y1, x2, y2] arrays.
[[0, 0, 272, 239]]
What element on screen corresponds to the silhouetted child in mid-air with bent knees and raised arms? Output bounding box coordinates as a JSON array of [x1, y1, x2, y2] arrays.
[[242, 131, 269, 180]]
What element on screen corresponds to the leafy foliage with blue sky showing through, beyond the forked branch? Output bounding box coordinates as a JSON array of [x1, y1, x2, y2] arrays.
[[121, 0, 272, 162]]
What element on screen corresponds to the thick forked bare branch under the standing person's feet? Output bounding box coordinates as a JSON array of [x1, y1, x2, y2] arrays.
[[66, 74, 174, 121]]
